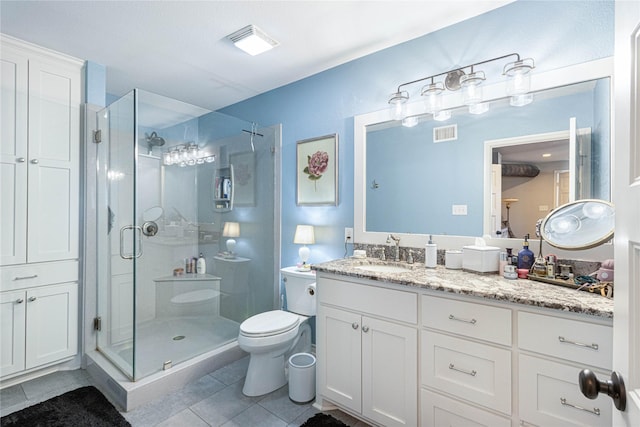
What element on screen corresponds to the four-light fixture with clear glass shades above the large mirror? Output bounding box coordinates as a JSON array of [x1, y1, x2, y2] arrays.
[[389, 53, 535, 120]]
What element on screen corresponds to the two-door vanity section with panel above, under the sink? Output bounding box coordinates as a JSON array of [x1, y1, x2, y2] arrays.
[[316, 278, 418, 426]]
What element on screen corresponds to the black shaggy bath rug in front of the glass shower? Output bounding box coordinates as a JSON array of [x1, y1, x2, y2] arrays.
[[0, 386, 131, 427]]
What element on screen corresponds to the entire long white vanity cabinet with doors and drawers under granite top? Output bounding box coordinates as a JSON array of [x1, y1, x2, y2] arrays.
[[315, 269, 613, 427]]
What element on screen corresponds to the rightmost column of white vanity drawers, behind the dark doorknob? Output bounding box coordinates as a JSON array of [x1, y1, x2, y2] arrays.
[[518, 312, 613, 426]]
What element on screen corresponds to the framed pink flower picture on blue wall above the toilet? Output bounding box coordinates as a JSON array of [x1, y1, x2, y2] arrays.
[[296, 134, 338, 206]]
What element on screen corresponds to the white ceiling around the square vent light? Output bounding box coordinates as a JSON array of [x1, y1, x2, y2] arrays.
[[0, 0, 513, 110]]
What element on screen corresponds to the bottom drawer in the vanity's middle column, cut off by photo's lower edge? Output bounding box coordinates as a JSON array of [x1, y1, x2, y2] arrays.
[[420, 389, 511, 427]]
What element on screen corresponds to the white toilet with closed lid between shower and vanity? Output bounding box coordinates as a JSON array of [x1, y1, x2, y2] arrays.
[[238, 267, 316, 396]]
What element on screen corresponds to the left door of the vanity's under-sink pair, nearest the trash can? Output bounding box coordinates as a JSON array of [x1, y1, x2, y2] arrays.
[[317, 306, 362, 412]]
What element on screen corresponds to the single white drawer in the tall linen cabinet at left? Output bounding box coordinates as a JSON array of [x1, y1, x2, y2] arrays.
[[0, 260, 79, 291]]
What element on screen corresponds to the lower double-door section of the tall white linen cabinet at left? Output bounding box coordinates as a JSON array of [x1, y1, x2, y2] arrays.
[[0, 283, 78, 378]]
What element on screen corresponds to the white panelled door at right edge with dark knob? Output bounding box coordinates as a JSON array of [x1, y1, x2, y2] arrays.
[[600, 1, 640, 426]]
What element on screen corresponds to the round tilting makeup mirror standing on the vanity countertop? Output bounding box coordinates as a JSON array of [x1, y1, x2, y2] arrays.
[[540, 199, 615, 250]]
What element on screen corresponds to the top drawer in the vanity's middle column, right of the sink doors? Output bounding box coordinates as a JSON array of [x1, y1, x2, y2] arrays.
[[422, 295, 511, 345]]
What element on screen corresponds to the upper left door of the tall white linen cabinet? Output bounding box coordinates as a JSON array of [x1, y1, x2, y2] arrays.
[[0, 44, 28, 265]]
